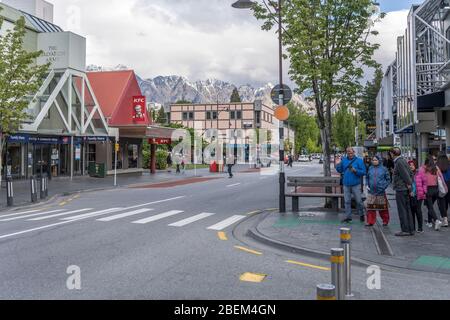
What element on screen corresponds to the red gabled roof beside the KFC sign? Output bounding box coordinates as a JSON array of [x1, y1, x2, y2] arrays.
[[87, 70, 151, 127]]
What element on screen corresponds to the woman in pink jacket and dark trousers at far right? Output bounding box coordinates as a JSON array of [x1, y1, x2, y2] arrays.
[[422, 156, 448, 231]]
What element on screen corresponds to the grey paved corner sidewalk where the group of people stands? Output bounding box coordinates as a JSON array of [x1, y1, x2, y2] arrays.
[[249, 194, 450, 274]]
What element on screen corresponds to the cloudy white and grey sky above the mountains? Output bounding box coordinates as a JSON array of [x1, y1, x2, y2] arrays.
[[53, 0, 422, 86]]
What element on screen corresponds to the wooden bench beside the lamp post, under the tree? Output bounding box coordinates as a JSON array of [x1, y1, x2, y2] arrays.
[[286, 177, 344, 212]]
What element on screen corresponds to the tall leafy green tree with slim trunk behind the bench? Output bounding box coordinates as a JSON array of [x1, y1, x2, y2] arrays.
[[253, 0, 384, 176]]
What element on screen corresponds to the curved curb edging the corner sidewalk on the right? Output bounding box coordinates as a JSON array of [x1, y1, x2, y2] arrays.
[[247, 213, 373, 268]]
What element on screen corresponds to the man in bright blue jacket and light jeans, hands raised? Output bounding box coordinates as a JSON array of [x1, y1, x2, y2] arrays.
[[336, 148, 366, 223]]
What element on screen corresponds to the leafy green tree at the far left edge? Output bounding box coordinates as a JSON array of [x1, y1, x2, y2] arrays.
[[0, 8, 49, 182]]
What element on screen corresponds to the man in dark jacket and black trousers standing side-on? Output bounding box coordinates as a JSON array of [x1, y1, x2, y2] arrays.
[[391, 148, 415, 237]]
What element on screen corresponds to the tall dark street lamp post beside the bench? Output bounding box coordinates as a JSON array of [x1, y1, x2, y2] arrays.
[[232, 0, 286, 213]]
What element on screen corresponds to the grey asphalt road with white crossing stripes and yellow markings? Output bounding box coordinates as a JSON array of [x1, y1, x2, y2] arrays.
[[0, 163, 450, 300]]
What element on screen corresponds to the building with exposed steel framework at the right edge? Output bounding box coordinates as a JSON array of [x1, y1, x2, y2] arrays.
[[377, 0, 450, 163]]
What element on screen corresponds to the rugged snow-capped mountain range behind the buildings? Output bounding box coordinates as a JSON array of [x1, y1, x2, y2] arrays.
[[87, 65, 315, 114]]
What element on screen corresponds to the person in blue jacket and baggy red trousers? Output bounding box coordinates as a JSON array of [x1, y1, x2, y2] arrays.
[[366, 156, 391, 227]]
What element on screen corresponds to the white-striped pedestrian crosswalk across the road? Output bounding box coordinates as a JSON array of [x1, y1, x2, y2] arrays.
[[0, 202, 245, 231]]
